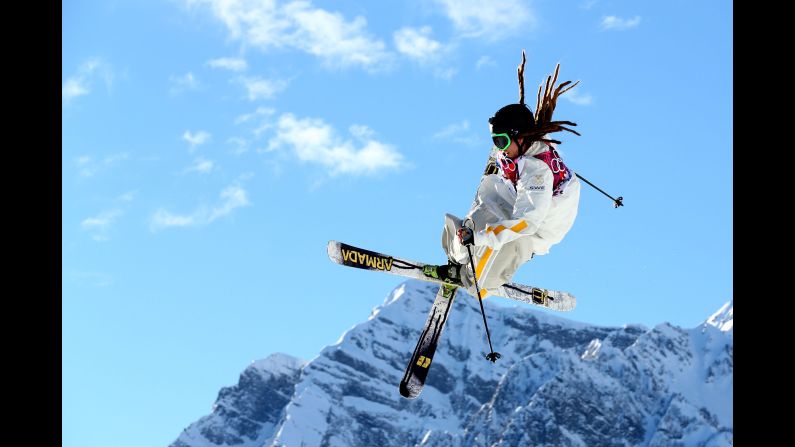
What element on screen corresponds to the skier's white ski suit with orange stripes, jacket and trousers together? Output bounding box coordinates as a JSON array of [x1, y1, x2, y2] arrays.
[[442, 142, 580, 298]]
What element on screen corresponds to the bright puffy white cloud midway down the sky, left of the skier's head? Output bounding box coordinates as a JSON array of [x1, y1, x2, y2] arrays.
[[268, 113, 403, 176]]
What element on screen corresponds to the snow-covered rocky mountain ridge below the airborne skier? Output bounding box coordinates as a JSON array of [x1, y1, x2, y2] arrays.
[[172, 281, 734, 447]]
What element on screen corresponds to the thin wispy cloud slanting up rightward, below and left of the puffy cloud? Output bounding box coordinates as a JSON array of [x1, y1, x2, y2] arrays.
[[149, 185, 251, 231]]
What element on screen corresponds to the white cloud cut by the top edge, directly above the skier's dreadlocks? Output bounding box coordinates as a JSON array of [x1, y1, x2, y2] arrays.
[[437, 0, 537, 41]]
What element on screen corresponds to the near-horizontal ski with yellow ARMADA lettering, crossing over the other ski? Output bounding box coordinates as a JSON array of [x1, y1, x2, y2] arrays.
[[328, 241, 577, 312]]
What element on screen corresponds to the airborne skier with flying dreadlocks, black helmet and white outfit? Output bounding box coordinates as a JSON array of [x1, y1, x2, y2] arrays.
[[423, 65, 580, 298]]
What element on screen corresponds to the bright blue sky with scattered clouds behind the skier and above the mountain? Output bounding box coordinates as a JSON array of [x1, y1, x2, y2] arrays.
[[62, 0, 733, 446]]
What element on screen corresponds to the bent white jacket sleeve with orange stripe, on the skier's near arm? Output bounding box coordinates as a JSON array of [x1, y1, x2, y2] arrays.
[[474, 157, 553, 250]]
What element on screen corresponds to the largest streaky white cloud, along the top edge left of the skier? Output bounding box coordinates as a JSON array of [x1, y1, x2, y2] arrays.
[[186, 0, 390, 70]]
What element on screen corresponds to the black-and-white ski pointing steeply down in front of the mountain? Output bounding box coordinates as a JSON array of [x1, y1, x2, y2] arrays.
[[400, 284, 458, 399]]
